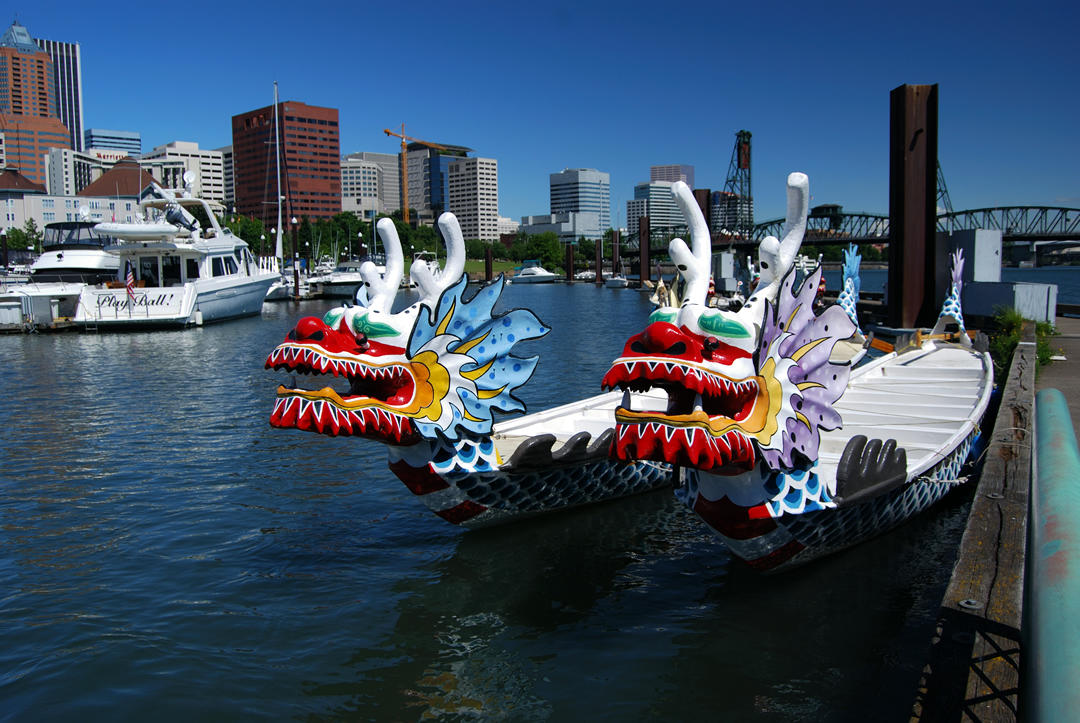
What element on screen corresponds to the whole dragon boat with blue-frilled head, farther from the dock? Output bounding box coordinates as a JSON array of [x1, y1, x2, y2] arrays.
[[266, 213, 672, 527]]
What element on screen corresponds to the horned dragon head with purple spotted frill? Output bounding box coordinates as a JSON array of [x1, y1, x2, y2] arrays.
[[603, 173, 853, 476]]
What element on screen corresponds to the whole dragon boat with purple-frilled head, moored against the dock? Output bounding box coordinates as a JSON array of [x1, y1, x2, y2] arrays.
[[603, 173, 993, 571]]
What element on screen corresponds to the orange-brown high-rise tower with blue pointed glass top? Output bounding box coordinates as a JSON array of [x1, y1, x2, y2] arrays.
[[0, 23, 71, 186]]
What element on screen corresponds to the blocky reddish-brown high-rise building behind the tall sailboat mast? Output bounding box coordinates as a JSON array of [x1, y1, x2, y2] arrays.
[[232, 101, 341, 226]]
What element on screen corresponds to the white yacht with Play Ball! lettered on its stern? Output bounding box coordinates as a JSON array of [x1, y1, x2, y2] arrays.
[[75, 179, 281, 329]]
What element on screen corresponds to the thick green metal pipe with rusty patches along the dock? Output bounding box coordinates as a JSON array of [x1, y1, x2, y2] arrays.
[[1024, 389, 1080, 721]]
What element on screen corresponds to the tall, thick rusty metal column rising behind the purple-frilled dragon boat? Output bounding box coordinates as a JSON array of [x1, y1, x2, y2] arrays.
[[889, 84, 937, 329]]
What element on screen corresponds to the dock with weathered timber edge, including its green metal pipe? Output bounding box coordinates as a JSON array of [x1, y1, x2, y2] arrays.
[[912, 317, 1080, 721]]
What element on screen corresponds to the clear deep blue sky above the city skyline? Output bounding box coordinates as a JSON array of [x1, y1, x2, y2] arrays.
[[19, 0, 1080, 225]]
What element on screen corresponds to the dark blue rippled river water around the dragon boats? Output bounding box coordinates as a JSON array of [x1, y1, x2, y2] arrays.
[[0, 284, 989, 721]]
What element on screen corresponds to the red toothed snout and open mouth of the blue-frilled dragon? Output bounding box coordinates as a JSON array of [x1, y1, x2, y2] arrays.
[[266, 317, 426, 445]]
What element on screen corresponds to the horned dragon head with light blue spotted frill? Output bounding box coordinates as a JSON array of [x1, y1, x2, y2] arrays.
[[266, 213, 548, 446]]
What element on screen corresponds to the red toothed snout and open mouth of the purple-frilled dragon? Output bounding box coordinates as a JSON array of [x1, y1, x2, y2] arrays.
[[603, 322, 769, 474]]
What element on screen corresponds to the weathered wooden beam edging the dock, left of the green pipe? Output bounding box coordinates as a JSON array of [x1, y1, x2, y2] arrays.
[[912, 324, 1036, 721]]
